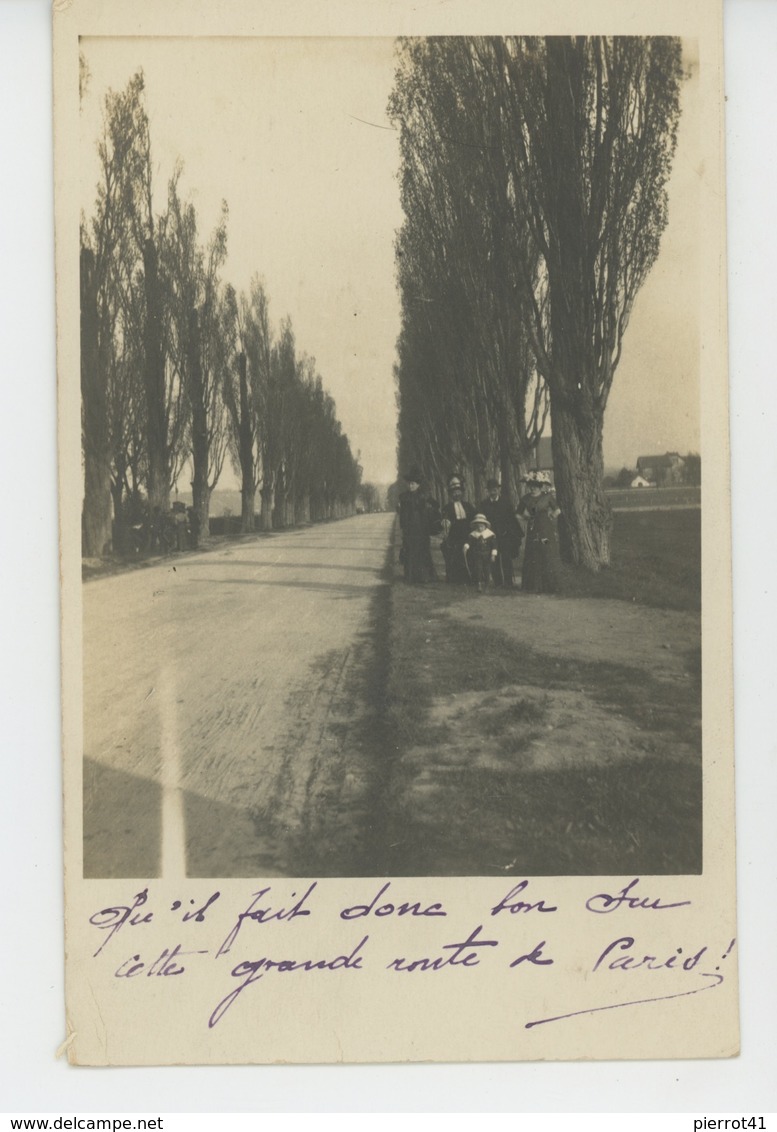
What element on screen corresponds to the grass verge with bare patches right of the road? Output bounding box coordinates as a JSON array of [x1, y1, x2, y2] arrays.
[[382, 513, 702, 876]]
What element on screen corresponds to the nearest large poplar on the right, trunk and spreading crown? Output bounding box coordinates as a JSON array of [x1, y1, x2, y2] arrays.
[[476, 36, 682, 571]]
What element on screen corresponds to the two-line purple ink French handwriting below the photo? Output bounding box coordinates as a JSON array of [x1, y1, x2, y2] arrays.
[[89, 877, 735, 1030]]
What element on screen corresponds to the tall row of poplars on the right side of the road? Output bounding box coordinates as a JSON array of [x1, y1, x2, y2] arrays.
[[389, 36, 682, 571]]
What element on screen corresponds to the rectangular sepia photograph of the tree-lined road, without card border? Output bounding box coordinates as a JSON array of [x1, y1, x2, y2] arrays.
[[80, 35, 706, 880]]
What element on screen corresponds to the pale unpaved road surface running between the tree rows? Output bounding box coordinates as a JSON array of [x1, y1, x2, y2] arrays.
[[84, 515, 393, 877]]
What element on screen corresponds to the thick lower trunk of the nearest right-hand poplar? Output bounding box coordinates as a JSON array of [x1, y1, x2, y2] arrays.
[[552, 398, 612, 573]]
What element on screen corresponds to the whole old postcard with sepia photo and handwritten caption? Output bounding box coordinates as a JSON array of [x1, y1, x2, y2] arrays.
[[53, 0, 738, 1065]]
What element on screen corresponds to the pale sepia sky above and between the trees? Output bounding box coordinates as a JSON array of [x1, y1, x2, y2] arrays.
[[80, 37, 700, 487]]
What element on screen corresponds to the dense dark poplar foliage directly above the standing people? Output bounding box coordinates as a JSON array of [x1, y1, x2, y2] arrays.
[[390, 38, 547, 502]]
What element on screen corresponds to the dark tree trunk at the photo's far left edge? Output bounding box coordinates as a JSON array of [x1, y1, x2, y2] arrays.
[[80, 248, 111, 558]]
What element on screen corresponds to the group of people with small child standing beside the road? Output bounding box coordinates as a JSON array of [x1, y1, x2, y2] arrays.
[[399, 468, 561, 593]]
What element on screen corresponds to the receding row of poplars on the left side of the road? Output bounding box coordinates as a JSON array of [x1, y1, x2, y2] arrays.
[[80, 67, 361, 556]]
